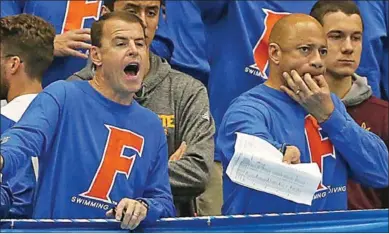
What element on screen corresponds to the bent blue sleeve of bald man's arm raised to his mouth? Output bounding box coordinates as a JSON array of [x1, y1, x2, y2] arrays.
[[320, 95, 388, 188]]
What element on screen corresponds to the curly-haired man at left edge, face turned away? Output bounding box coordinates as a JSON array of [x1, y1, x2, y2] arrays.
[[0, 14, 55, 218]]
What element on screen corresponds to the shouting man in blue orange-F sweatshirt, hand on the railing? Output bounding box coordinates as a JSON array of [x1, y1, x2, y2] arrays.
[[0, 12, 175, 229]]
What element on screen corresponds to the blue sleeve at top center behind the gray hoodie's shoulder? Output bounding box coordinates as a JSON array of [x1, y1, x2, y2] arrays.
[[166, 0, 210, 86]]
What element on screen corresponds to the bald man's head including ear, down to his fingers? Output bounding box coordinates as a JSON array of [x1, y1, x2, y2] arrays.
[[268, 14, 327, 85]]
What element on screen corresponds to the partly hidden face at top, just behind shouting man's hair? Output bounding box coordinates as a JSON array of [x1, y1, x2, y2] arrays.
[[114, 0, 161, 45]]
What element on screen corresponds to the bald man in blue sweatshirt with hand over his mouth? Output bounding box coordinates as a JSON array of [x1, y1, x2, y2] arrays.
[[216, 14, 388, 215]]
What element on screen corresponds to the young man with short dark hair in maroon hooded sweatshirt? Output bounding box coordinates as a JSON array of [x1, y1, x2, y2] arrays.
[[311, 0, 389, 210]]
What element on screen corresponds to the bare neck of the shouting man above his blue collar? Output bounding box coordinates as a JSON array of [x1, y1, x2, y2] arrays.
[[89, 73, 134, 106]]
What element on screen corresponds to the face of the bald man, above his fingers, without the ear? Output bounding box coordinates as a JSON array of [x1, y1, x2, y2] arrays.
[[280, 21, 327, 76]]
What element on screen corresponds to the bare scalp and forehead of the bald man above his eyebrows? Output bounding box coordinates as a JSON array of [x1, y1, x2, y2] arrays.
[[269, 14, 324, 47]]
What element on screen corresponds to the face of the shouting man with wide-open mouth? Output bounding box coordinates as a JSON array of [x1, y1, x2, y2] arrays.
[[100, 19, 148, 94]]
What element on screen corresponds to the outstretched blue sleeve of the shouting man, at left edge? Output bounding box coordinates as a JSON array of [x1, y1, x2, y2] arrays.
[[0, 81, 65, 182]]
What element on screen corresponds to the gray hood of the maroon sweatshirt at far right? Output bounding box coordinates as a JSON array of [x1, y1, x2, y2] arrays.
[[342, 73, 372, 107]]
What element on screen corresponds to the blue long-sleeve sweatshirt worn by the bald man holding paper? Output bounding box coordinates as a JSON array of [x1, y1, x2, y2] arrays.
[[216, 84, 388, 214]]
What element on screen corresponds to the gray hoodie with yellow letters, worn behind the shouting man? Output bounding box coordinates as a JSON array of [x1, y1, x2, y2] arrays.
[[68, 53, 215, 216]]
